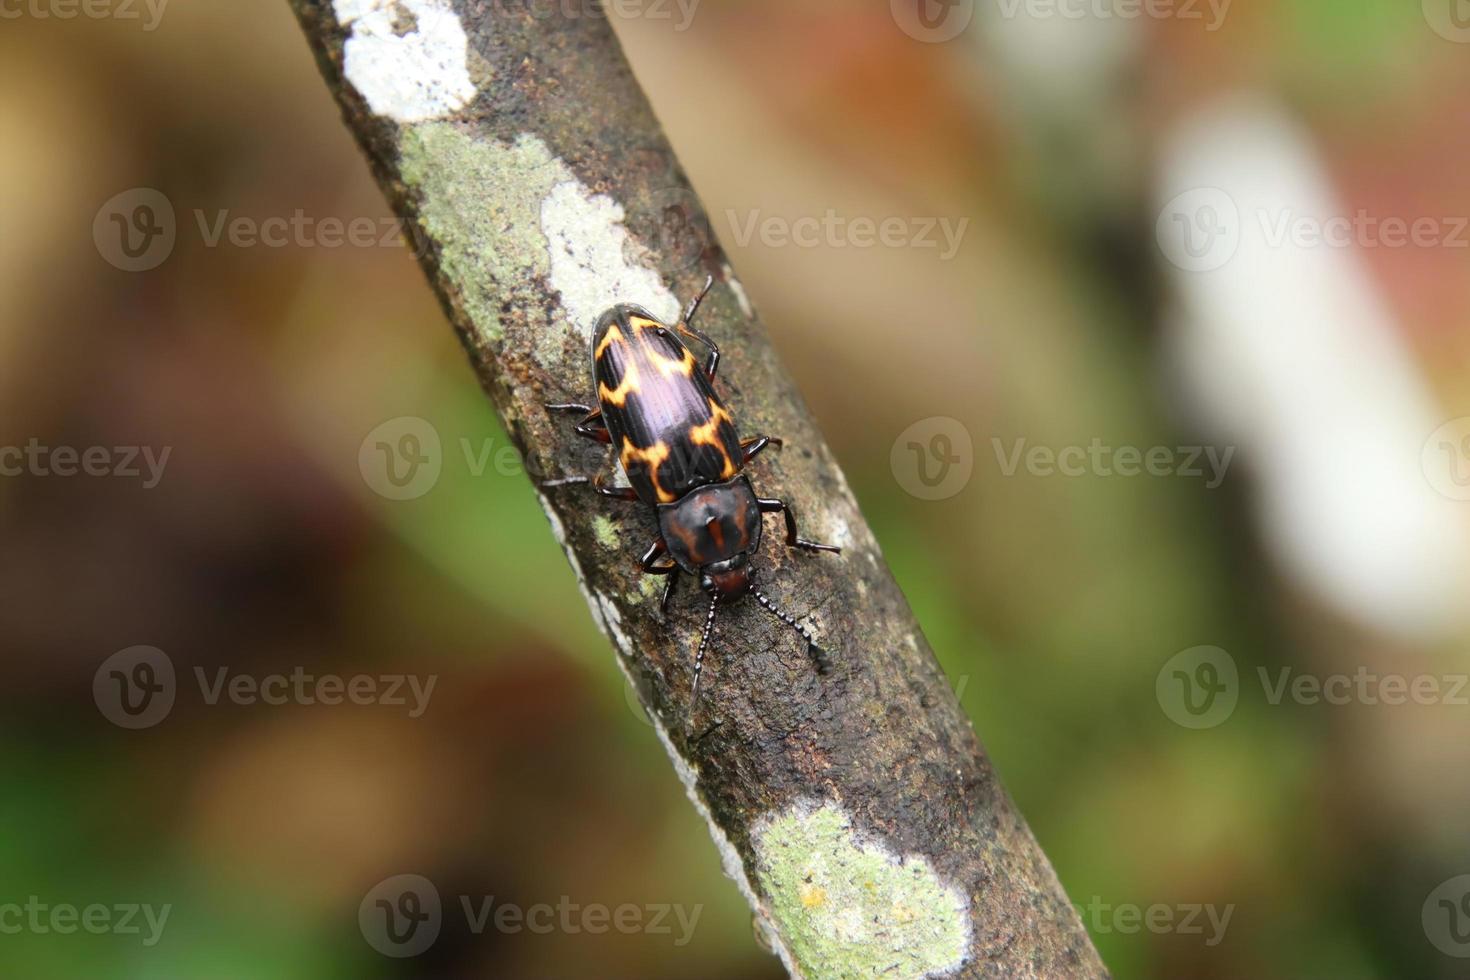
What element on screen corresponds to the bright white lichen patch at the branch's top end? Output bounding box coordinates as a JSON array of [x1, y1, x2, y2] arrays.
[[332, 0, 478, 122]]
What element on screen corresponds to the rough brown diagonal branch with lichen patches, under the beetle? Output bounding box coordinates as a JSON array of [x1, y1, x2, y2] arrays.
[[291, 0, 1107, 977]]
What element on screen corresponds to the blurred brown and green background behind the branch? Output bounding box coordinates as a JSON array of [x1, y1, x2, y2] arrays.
[[0, 0, 1470, 980]]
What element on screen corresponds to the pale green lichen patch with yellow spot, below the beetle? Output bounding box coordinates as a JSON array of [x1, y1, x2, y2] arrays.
[[754, 802, 970, 980]]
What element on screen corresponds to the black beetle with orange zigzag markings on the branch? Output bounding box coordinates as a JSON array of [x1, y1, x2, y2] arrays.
[[542, 276, 841, 716]]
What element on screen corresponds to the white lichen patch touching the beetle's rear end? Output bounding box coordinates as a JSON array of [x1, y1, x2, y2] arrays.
[[541, 179, 679, 342]]
